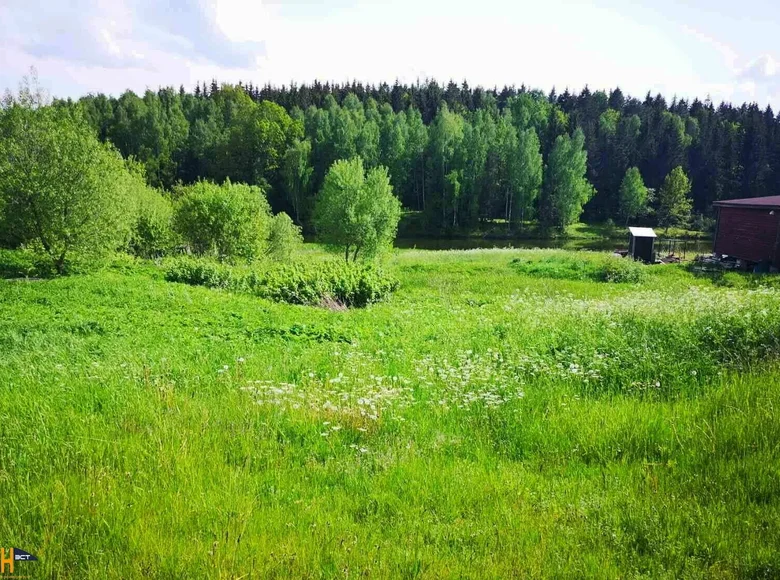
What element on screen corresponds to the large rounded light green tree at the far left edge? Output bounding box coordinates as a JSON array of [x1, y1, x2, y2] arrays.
[[0, 104, 134, 274]]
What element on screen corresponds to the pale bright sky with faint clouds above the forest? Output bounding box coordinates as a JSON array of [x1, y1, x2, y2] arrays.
[[0, 0, 780, 111]]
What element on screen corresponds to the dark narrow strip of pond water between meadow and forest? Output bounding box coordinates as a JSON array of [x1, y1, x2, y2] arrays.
[[395, 238, 712, 255]]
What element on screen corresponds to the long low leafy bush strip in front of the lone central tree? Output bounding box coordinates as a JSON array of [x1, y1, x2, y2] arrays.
[[165, 257, 398, 307]]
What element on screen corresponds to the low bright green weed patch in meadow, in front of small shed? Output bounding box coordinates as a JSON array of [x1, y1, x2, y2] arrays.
[[512, 251, 647, 284]]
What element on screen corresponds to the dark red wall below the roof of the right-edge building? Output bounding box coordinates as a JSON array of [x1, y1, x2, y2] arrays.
[[715, 207, 780, 265]]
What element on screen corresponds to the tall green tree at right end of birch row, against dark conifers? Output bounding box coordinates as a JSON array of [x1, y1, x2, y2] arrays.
[[540, 129, 594, 230]]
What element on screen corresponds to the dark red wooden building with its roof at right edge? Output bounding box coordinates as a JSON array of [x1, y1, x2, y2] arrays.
[[714, 195, 780, 267]]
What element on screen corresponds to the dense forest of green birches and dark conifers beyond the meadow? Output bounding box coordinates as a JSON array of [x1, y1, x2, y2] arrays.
[[65, 81, 780, 233]]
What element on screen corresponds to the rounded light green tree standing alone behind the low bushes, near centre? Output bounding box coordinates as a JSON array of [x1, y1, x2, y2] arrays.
[[314, 157, 401, 261]]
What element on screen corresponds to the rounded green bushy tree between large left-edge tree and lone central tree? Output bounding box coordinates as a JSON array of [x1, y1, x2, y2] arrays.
[[173, 180, 271, 261]]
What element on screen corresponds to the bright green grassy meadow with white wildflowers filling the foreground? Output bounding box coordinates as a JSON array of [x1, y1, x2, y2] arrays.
[[0, 250, 780, 579]]
